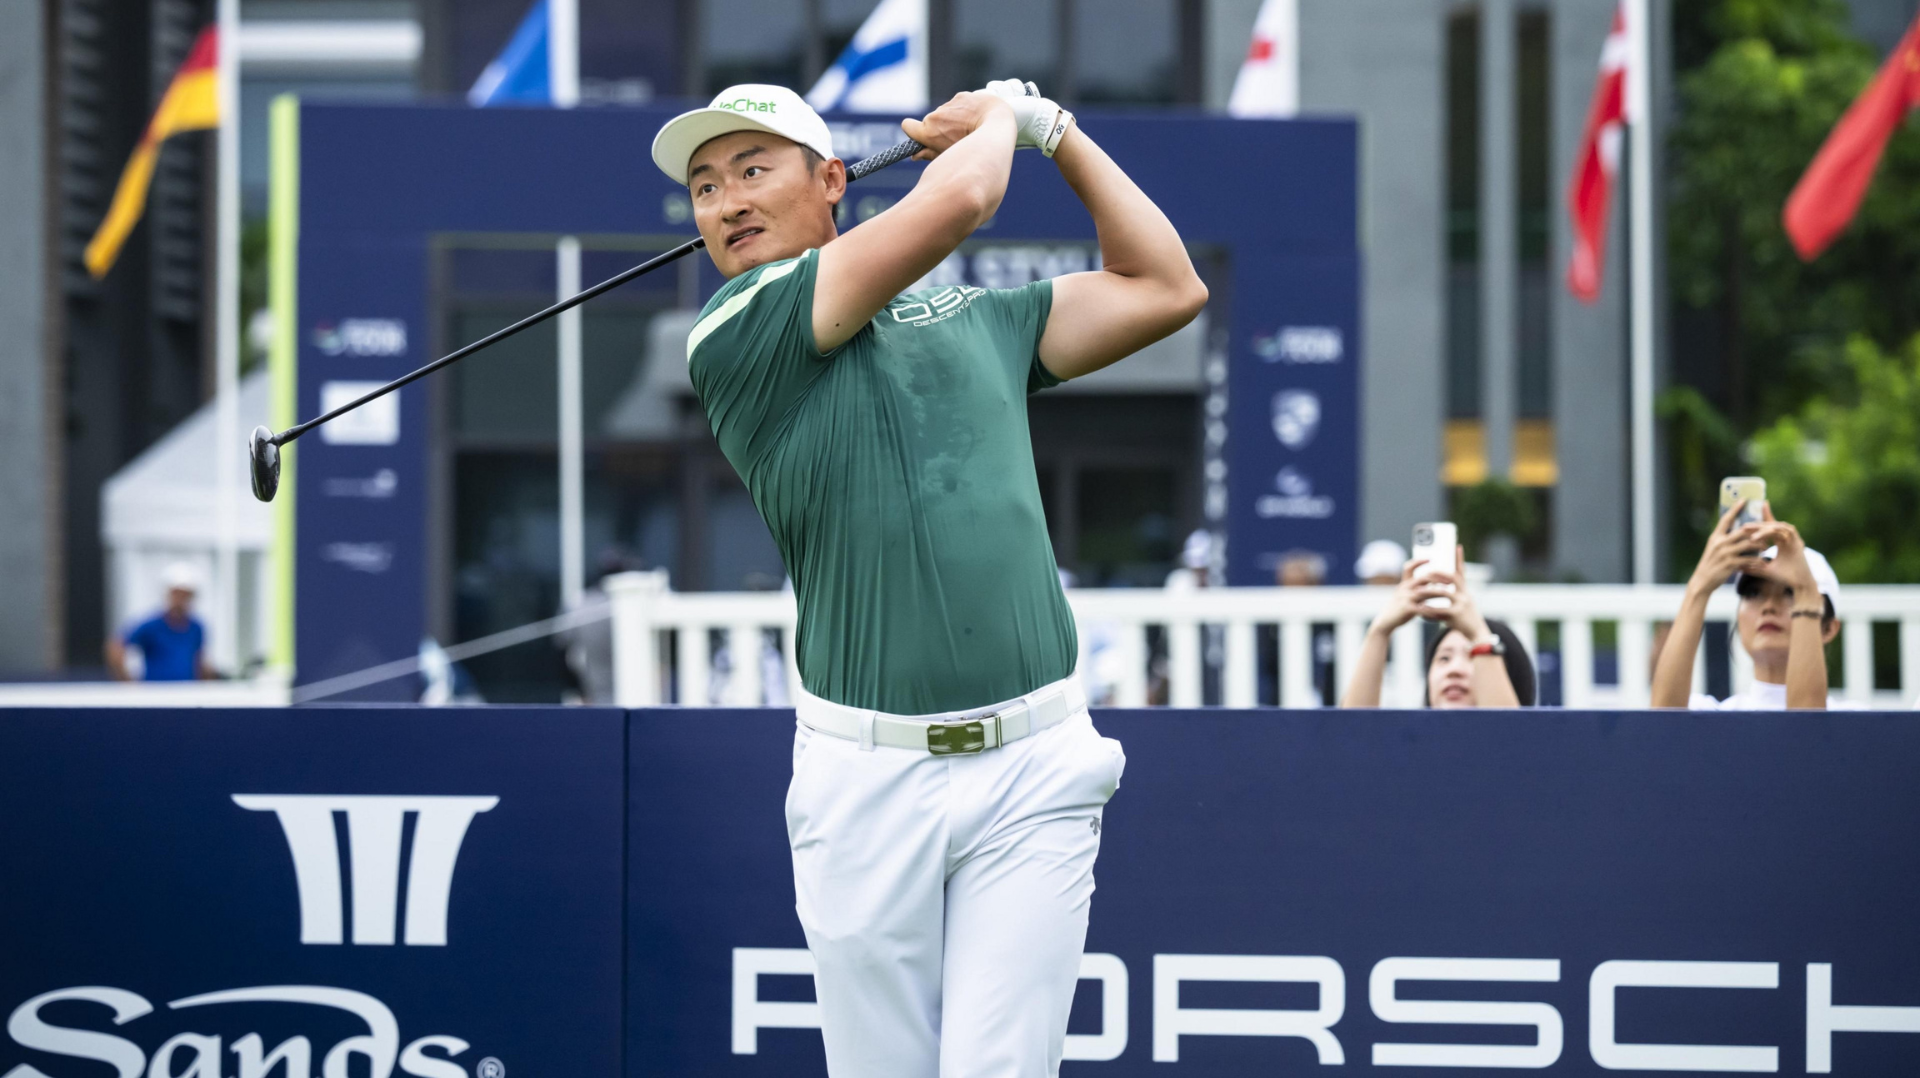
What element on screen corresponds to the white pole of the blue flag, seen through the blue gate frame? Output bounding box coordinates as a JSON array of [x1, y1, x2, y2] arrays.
[[547, 0, 586, 613]]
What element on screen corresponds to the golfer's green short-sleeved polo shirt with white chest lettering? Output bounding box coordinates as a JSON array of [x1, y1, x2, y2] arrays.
[[687, 252, 1079, 715]]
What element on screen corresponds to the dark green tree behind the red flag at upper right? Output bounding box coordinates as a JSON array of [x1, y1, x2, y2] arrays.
[[1668, 0, 1920, 427]]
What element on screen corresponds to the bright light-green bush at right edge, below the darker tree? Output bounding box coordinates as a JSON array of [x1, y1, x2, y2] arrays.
[[1751, 336, 1920, 584]]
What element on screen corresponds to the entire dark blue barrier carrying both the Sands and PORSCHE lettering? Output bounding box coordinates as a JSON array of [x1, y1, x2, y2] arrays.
[[18, 709, 1920, 1078]]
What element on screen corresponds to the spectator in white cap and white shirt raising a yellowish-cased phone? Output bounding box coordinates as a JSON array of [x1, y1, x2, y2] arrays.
[[1653, 502, 1849, 711]]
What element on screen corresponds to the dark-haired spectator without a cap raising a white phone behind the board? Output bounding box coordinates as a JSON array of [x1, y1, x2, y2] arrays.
[[1340, 551, 1534, 709]]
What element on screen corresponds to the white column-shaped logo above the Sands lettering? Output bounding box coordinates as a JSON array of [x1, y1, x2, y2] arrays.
[[234, 794, 499, 947]]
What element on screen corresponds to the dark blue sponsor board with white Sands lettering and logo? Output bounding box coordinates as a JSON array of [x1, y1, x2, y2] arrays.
[[0, 709, 626, 1078]]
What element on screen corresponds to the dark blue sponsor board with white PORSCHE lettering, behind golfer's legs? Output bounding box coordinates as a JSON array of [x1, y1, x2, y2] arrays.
[[628, 711, 1920, 1078]]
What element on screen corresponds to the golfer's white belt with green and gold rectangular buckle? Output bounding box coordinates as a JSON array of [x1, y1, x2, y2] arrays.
[[795, 676, 1087, 755]]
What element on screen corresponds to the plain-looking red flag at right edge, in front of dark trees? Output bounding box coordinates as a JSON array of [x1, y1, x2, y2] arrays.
[[1784, 19, 1920, 261]]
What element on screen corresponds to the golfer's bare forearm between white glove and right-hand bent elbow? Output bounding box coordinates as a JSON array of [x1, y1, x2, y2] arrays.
[[1054, 125, 1206, 295]]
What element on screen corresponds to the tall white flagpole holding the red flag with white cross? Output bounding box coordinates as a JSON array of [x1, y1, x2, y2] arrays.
[[1626, 0, 1655, 584]]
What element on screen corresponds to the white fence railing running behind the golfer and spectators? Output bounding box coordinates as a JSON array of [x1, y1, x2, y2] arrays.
[[607, 573, 1920, 707]]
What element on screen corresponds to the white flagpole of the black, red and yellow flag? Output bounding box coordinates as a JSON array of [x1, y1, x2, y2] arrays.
[[213, 0, 246, 674]]
